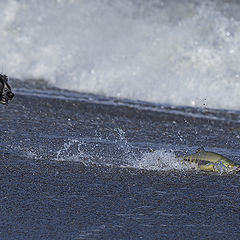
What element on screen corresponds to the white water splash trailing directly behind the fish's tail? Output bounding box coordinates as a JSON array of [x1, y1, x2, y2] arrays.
[[55, 136, 190, 171]]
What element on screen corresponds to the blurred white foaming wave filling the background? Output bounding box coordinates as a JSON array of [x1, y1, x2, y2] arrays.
[[0, 0, 240, 110]]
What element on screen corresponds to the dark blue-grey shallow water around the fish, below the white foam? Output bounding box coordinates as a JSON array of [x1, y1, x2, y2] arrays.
[[0, 83, 240, 239]]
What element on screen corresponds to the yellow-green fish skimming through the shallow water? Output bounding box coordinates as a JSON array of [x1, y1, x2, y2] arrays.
[[178, 147, 240, 174]]
